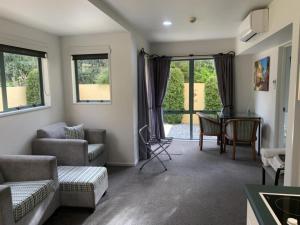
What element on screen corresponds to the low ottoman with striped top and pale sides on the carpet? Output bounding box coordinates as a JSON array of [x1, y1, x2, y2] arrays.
[[58, 166, 108, 208]]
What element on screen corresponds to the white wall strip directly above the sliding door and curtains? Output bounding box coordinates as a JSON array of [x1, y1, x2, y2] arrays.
[[150, 38, 235, 56]]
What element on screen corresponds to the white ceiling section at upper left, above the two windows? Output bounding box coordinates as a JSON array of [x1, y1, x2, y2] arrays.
[[0, 0, 124, 35]]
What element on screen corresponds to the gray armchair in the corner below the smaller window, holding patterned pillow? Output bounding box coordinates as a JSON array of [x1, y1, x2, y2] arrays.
[[32, 122, 107, 166]]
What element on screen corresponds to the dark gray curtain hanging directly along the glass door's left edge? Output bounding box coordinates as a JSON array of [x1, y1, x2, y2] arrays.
[[154, 57, 171, 138]]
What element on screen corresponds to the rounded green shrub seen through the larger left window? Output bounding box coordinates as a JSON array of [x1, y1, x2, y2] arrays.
[[26, 69, 41, 105]]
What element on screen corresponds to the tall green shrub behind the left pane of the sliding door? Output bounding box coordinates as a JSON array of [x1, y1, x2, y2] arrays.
[[163, 67, 184, 124]]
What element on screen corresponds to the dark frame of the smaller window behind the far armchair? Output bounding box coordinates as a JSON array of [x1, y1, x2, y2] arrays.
[[72, 53, 112, 104]]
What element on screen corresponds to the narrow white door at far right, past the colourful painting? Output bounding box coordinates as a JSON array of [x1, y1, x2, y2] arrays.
[[277, 45, 292, 148]]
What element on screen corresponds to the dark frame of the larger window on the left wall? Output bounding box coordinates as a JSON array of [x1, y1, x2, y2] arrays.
[[0, 44, 47, 115]]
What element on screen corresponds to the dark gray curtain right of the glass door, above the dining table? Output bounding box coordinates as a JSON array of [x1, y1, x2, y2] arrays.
[[214, 53, 234, 114]]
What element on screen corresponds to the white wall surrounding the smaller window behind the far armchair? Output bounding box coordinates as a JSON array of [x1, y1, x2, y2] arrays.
[[62, 32, 138, 165]]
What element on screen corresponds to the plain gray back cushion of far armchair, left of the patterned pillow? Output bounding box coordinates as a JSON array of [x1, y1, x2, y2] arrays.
[[37, 122, 67, 139]]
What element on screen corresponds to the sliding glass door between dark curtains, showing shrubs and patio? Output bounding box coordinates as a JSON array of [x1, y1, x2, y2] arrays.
[[163, 59, 221, 139]]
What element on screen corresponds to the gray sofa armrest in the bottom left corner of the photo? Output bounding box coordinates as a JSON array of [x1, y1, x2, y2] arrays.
[[0, 185, 15, 225]]
